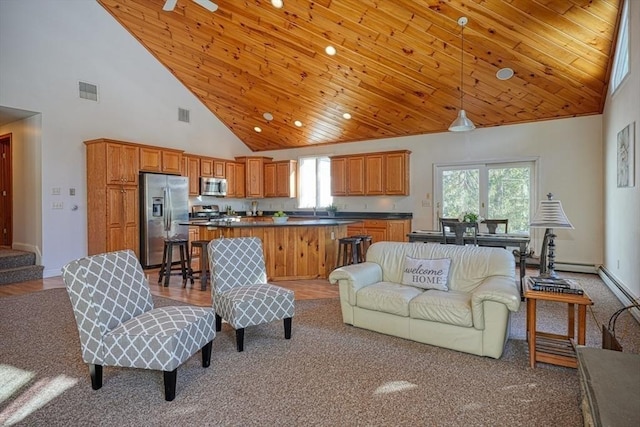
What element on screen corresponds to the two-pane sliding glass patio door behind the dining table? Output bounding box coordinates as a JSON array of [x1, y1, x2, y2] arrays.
[[434, 161, 536, 233]]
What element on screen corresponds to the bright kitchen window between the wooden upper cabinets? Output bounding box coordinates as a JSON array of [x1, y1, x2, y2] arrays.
[[298, 156, 333, 209]]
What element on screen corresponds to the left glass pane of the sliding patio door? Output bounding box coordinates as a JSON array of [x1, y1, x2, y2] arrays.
[[441, 169, 480, 218]]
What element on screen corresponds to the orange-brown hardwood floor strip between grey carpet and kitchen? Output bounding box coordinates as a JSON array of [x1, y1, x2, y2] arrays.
[[0, 262, 339, 307]]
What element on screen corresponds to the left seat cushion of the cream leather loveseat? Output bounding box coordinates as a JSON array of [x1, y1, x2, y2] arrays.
[[356, 282, 424, 317]]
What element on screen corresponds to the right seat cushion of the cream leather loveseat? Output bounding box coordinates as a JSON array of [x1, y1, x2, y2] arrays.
[[409, 290, 473, 328]]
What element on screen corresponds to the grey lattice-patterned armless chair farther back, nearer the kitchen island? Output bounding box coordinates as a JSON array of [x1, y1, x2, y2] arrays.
[[208, 237, 295, 351]]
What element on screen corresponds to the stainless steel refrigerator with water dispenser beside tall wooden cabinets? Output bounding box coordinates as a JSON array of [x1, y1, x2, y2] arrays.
[[140, 173, 189, 268]]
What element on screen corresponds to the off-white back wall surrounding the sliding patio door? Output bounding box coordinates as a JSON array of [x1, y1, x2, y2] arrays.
[[261, 115, 604, 266]]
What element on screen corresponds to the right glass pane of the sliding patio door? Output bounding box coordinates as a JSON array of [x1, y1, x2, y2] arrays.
[[487, 167, 531, 233]]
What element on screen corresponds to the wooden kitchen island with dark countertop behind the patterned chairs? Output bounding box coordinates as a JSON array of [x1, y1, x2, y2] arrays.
[[183, 217, 355, 281]]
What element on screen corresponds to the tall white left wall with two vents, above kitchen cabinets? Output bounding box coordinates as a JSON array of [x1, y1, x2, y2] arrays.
[[0, 0, 250, 276]]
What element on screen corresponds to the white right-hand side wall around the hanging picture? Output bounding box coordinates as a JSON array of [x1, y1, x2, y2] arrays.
[[603, 0, 640, 299]]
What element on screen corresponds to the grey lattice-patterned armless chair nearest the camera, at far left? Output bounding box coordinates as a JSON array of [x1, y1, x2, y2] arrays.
[[62, 250, 216, 401]]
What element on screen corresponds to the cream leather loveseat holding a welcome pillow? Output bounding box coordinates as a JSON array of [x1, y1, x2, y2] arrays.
[[329, 242, 520, 359]]
